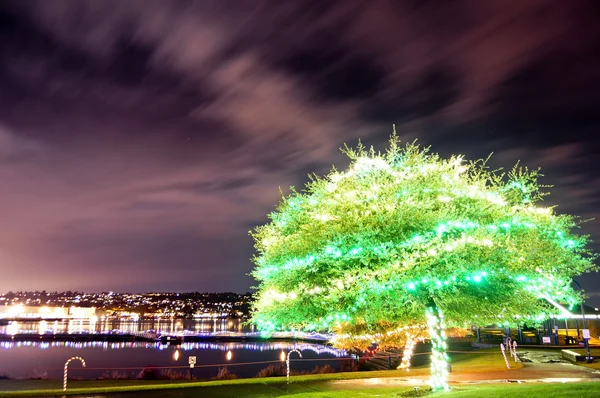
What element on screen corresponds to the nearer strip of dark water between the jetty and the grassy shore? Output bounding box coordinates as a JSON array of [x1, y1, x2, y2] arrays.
[[0, 342, 347, 380]]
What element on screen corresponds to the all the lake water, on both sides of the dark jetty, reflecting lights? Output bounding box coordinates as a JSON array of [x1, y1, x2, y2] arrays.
[[0, 320, 351, 379]]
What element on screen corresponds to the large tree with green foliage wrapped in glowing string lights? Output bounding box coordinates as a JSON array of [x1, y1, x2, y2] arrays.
[[252, 136, 595, 387]]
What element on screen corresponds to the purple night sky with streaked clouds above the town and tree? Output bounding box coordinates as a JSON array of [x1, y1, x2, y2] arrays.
[[0, 0, 600, 305]]
